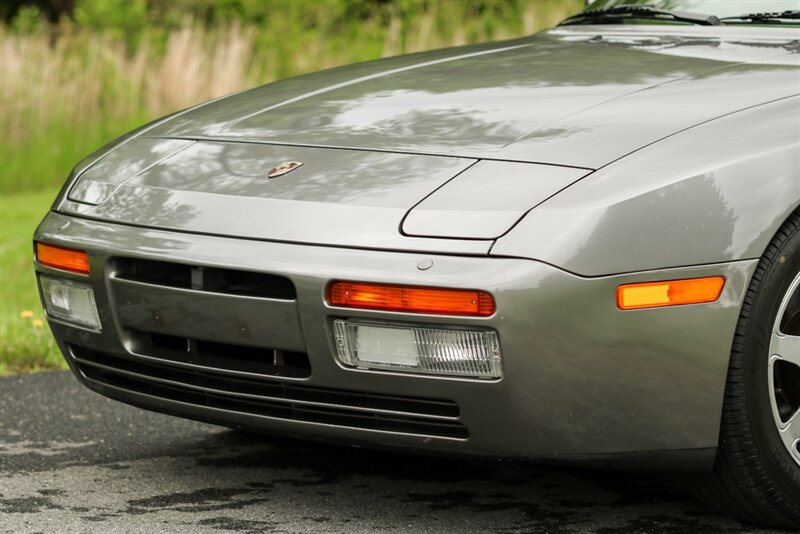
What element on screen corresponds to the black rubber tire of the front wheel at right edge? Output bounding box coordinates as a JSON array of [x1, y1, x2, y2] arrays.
[[693, 209, 800, 529]]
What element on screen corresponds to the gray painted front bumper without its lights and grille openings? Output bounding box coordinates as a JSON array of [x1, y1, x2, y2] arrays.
[[35, 213, 757, 468]]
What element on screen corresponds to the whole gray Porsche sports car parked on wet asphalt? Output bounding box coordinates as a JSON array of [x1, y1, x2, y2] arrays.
[[34, 0, 800, 527]]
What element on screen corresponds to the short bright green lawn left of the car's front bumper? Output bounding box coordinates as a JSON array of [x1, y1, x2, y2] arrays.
[[0, 189, 66, 375]]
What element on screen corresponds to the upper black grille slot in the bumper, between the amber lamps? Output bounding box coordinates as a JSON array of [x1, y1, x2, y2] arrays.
[[113, 258, 297, 300]]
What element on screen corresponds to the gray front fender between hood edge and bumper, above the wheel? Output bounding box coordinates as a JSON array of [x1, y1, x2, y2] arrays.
[[491, 95, 800, 276]]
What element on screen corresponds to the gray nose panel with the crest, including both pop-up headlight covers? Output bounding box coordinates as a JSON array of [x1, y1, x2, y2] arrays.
[[61, 137, 589, 254]]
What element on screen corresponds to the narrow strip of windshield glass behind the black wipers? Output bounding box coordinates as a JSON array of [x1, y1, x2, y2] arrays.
[[586, 0, 800, 18]]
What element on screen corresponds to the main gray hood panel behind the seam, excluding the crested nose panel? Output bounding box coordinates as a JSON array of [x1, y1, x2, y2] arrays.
[[148, 26, 800, 168]]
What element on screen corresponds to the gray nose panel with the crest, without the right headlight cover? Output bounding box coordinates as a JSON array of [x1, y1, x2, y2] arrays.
[[64, 139, 491, 254]]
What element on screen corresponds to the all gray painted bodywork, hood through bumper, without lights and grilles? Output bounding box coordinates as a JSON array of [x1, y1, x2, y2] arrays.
[[35, 18, 800, 465]]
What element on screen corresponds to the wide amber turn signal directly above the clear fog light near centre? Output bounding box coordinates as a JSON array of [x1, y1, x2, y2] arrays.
[[326, 282, 497, 317]]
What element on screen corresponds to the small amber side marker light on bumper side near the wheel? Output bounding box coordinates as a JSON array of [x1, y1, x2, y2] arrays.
[[617, 276, 725, 310]]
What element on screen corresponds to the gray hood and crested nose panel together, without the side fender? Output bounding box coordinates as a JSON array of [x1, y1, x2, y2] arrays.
[[62, 27, 800, 254]]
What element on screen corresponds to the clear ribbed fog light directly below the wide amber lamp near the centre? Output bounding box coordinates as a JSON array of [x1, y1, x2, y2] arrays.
[[333, 319, 503, 378]]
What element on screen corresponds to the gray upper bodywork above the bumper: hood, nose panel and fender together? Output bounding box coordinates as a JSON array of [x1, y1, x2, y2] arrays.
[[56, 25, 800, 268]]
